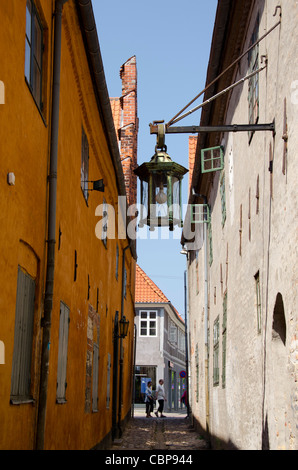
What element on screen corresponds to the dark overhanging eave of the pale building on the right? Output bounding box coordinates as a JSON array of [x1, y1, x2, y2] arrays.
[[181, 0, 254, 245]]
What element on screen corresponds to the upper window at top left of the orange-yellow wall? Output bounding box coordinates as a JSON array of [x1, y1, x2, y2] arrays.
[[25, 0, 44, 110]]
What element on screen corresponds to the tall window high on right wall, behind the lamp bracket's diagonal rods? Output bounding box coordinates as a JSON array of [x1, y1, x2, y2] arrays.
[[248, 16, 259, 140]]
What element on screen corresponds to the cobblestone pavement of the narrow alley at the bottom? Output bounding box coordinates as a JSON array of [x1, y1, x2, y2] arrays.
[[108, 410, 208, 451]]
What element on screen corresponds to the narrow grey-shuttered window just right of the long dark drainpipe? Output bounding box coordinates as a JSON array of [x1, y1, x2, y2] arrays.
[[56, 302, 70, 403]]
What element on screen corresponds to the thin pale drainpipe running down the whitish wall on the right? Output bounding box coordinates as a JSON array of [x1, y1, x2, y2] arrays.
[[192, 189, 210, 434]]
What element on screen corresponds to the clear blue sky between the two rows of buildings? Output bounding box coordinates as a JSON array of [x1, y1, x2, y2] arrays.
[[92, 0, 217, 317]]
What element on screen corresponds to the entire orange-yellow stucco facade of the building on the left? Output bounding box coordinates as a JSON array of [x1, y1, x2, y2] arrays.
[[0, 0, 136, 449]]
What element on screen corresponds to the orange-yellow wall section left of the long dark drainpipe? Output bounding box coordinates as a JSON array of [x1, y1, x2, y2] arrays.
[[0, 0, 52, 449]]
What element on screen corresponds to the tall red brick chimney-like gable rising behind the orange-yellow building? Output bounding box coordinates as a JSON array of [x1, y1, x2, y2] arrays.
[[111, 56, 139, 205]]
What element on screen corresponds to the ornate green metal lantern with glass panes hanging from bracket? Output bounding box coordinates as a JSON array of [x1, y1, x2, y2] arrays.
[[134, 124, 188, 231]]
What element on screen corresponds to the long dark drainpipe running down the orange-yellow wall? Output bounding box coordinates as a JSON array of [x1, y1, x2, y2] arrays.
[[36, 0, 68, 450]]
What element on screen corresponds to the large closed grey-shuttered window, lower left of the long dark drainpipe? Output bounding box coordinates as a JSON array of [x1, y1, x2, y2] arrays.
[[10, 266, 35, 404]]
